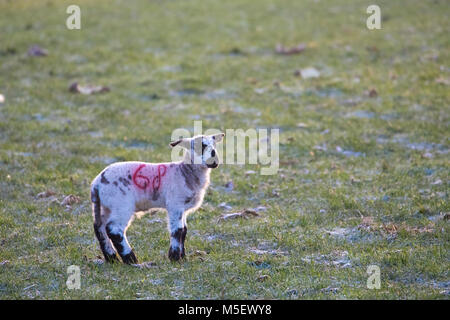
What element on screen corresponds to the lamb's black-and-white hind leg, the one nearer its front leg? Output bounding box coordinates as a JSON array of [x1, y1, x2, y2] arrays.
[[106, 212, 138, 264]]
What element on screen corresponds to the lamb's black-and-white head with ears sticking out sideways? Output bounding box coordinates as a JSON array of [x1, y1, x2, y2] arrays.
[[170, 133, 225, 169]]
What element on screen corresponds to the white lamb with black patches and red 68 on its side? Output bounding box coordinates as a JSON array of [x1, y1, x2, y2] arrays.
[[91, 133, 224, 264]]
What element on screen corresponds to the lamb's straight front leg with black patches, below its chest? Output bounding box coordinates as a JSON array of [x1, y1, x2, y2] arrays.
[[168, 209, 187, 261]]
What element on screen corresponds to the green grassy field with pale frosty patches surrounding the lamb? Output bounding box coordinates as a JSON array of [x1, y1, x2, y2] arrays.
[[0, 0, 450, 299]]
